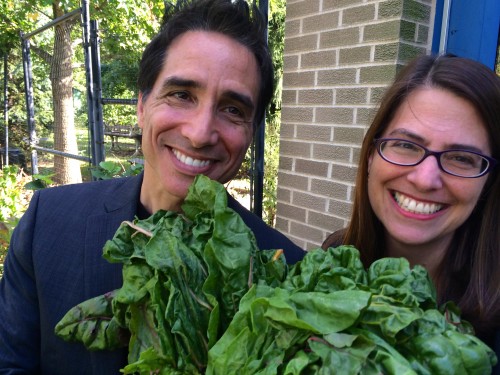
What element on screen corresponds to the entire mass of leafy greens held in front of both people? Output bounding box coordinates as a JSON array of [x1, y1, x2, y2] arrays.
[[56, 176, 496, 375]]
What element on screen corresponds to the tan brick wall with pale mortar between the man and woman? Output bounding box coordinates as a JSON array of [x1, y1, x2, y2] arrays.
[[276, 0, 435, 249]]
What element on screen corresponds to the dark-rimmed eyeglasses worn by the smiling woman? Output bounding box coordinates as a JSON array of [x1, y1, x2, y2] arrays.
[[374, 138, 497, 178]]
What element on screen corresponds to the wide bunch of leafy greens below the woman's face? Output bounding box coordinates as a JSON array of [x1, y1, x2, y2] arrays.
[[206, 246, 497, 375]]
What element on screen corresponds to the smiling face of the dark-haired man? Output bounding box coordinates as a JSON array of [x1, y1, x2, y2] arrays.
[[137, 31, 260, 213]]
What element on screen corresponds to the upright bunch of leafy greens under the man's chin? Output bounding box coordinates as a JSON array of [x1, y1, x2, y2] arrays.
[[55, 176, 286, 374]]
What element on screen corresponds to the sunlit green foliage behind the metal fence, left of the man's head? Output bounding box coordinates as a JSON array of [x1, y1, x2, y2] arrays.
[[0, 0, 164, 158]]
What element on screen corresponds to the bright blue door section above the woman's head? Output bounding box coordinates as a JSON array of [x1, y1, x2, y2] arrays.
[[432, 0, 500, 70]]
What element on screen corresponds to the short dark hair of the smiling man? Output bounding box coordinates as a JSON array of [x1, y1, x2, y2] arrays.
[[138, 0, 274, 128]]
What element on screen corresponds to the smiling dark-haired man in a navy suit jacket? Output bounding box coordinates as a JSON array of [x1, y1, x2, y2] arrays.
[[0, 0, 304, 375]]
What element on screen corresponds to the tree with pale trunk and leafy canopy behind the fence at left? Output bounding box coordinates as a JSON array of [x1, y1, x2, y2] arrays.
[[0, 0, 163, 184]]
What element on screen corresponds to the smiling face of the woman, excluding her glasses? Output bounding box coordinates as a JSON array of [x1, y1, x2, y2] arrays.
[[368, 88, 492, 253]]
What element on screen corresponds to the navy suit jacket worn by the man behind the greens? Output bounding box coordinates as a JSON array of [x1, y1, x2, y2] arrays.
[[0, 175, 305, 375]]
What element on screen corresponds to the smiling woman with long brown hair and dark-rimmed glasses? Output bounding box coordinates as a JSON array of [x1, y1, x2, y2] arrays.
[[323, 55, 500, 364]]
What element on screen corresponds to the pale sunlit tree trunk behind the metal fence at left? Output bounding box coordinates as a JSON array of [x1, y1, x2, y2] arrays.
[[50, 6, 82, 184]]
